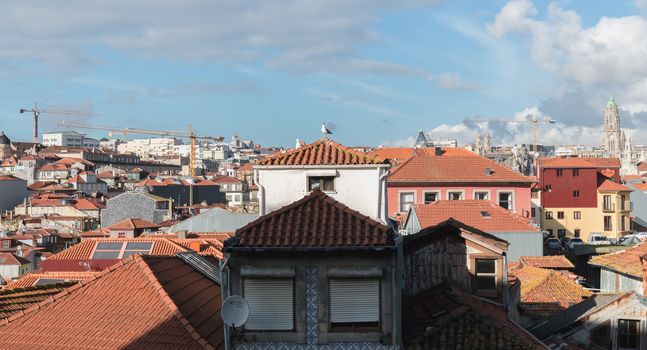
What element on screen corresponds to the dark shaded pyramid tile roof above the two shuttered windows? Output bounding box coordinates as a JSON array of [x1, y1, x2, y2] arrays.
[[224, 190, 395, 251]]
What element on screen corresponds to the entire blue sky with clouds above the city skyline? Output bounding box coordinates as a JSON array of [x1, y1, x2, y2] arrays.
[[0, 0, 647, 146]]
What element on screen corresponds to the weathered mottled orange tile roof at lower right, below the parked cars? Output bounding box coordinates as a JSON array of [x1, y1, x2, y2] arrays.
[[509, 266, 593, 312]]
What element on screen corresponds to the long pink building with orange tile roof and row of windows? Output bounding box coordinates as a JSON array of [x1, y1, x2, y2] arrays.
[[372, 148, 536, 218]]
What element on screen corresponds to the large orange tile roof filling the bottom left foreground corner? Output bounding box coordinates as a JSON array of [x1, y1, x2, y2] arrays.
[[0, 256, 224, 349]]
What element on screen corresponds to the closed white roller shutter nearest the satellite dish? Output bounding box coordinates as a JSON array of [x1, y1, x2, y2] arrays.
[[243, 278, 294, 330]]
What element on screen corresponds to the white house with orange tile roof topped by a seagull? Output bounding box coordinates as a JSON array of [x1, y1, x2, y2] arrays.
[[254, 138, 391, 222]]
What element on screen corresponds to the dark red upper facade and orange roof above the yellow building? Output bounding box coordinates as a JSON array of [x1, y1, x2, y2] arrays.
[[538, 158, 621, 208]]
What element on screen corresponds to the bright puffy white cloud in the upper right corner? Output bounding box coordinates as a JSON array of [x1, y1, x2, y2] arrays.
[[486, 0, 647, 112]]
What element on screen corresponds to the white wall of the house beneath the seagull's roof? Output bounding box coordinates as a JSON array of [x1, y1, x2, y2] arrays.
[[255, 166, 388, 221]]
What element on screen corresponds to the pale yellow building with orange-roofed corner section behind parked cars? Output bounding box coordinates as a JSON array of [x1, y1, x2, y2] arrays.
[[541, 180, 632, 242]]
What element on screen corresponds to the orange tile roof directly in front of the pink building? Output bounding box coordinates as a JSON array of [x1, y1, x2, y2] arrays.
[[413, 200, 539, 232]]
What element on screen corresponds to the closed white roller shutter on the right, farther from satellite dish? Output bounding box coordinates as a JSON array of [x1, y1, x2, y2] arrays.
[[330, 278, 380, 323]]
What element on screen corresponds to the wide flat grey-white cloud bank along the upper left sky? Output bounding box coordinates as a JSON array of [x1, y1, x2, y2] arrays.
[[0, 0, 436, 75]]
